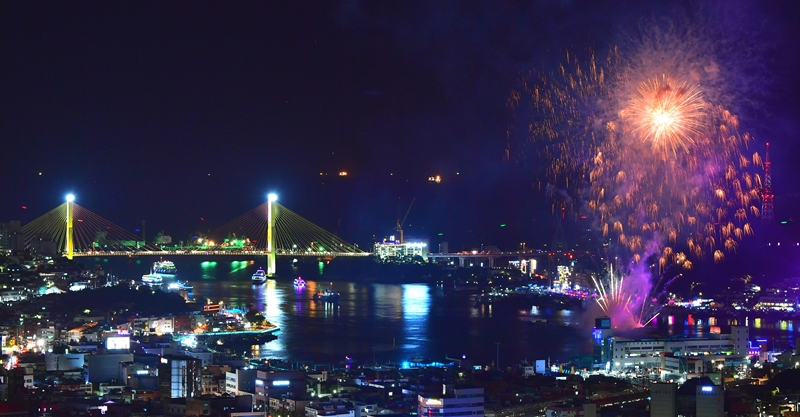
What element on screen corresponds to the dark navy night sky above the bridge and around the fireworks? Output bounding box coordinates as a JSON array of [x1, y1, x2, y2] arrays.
[[0, 0, 800, 254]]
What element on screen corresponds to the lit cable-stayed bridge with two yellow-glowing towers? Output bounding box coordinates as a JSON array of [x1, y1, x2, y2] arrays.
[[22, 195, 371, 274]]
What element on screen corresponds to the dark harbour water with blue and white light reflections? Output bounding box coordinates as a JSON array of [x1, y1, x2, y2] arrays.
[[97, 258, 794, 364]]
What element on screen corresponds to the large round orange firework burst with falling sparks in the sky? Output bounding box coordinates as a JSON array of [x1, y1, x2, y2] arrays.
[[509, 23, 763, 273]]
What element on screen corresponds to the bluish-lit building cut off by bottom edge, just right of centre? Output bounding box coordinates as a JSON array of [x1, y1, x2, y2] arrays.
[[417, 384, 484, 417]]
